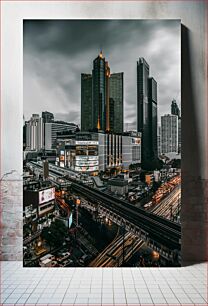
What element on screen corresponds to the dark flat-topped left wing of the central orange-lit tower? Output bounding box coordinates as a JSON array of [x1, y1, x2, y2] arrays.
[[81, 73, 93, 131]]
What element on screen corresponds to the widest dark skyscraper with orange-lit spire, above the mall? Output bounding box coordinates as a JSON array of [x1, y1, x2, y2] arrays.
[[81, 52, 123, 133]]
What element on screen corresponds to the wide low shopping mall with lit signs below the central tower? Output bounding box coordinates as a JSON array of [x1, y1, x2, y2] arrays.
[[57, 132, 141, 174]]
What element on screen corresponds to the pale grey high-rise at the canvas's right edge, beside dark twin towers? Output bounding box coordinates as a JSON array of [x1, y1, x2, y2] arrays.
[[161, 114, 178, 154]]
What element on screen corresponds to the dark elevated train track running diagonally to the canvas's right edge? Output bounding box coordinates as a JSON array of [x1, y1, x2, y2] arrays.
[[71, 183, 181, 250]]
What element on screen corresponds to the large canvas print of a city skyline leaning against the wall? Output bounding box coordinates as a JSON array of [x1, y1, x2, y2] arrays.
[[23, 19, 181, 268]]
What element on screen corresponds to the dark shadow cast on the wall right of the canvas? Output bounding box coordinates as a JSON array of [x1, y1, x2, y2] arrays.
[[181, 25, 208, 266]]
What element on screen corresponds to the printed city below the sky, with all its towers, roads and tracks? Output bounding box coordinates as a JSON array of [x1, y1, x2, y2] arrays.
[[23, 20, 181, 267]]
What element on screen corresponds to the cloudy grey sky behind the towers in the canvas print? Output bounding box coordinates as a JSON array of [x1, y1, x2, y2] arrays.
[[24, 20, 181, 124]]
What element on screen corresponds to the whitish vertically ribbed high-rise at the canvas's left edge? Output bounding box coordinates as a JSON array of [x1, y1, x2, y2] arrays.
[[25, 114, 44, 151]]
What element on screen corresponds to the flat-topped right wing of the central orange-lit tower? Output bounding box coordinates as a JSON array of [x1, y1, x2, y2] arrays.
[[109, 72, 124, 134]]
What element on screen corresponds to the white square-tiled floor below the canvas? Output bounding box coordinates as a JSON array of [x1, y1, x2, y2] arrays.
[[0, 261, 208, 306]]
